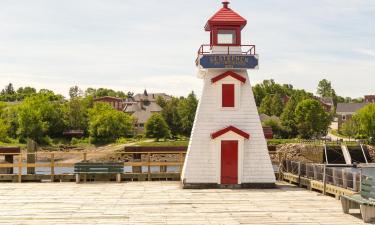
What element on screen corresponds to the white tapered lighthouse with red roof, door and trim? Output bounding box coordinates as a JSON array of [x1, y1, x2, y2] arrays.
[[181, 1, 275, 188]]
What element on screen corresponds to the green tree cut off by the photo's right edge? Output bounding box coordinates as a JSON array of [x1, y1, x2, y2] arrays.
[[354, 103, 375, 143]]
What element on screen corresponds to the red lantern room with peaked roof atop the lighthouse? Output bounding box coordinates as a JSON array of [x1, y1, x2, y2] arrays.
[[205, 1, 247, 46]]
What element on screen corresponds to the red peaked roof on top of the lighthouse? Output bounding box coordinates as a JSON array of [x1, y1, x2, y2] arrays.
[[205, 1, 247, 31]]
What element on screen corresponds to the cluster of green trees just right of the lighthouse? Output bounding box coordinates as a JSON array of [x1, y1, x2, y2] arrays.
[[253, 79, 369, 139]]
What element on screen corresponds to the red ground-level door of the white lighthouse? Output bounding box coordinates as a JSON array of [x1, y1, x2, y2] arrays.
[[221, 141, 238, 184]]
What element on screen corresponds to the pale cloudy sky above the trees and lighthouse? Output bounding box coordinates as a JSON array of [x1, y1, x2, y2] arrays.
[[0, 0, 375, 97]]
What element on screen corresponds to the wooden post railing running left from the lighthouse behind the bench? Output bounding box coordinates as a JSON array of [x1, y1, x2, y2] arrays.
[[0, 151, 186, 182]]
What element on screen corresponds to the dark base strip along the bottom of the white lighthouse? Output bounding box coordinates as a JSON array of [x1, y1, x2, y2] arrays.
[[182, 183, 276, 189]]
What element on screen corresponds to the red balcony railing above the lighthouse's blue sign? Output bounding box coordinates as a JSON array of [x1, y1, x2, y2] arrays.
[[195, 44, 256, 65]]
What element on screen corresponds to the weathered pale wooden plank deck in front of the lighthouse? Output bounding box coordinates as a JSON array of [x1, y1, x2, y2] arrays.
[[0, 181, 363, 225]]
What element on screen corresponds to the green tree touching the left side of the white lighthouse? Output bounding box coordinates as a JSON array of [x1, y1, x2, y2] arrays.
[[178, 92, 198, 136]]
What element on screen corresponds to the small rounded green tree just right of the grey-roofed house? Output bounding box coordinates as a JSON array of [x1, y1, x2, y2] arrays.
[[146, 113, 170, 141]]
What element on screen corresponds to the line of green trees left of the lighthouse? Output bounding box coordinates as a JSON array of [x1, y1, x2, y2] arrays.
[[0, 84, 197, 144]]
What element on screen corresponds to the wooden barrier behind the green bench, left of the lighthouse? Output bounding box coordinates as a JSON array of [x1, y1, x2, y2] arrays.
[[0, 151, 186, 182]]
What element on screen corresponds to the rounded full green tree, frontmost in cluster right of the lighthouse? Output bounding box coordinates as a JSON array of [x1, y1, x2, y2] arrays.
[[295, 99, 331, 138]]
